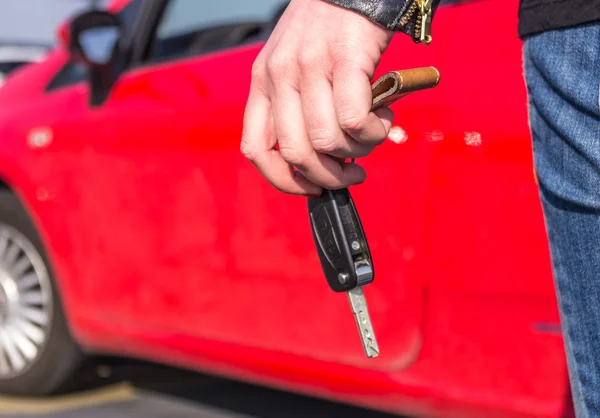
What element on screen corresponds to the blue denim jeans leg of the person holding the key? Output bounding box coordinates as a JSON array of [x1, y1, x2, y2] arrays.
[[524, 23, 600, 418]]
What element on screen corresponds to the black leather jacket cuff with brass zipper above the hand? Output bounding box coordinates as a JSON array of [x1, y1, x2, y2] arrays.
[[326, 0, 440, 41]]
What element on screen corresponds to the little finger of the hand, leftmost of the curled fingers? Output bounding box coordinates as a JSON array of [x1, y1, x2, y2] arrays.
[[240, 89, 322, 195]]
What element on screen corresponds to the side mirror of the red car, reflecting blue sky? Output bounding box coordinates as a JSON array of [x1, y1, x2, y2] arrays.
[[69, 10, 122, 106]]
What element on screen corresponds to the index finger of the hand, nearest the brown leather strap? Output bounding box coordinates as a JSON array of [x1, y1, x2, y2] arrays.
[[333, 69, 391, 146]]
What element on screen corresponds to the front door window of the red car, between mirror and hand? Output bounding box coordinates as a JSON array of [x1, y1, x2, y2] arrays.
[[148, 0, 288, 62]]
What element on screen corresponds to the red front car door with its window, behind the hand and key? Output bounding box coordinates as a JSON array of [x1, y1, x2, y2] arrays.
[[45, 0, 427, 369]]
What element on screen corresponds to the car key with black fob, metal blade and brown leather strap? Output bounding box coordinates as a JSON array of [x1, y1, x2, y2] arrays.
[[308, 67, 440, 358]]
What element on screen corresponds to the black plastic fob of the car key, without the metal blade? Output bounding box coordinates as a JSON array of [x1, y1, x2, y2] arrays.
[[308, 189, 375, 292]]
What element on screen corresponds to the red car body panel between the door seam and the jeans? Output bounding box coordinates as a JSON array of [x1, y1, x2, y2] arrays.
[[404, 0, 566, 404]]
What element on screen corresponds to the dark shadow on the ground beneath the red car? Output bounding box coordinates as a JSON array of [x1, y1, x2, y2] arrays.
[[62, 358, 398, 418]]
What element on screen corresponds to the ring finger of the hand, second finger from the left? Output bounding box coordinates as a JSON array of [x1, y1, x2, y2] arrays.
[[272, 83, 366, 190]]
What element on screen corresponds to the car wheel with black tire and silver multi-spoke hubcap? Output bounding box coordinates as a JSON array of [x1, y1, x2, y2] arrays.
[[0, 190, 83, 396]]
